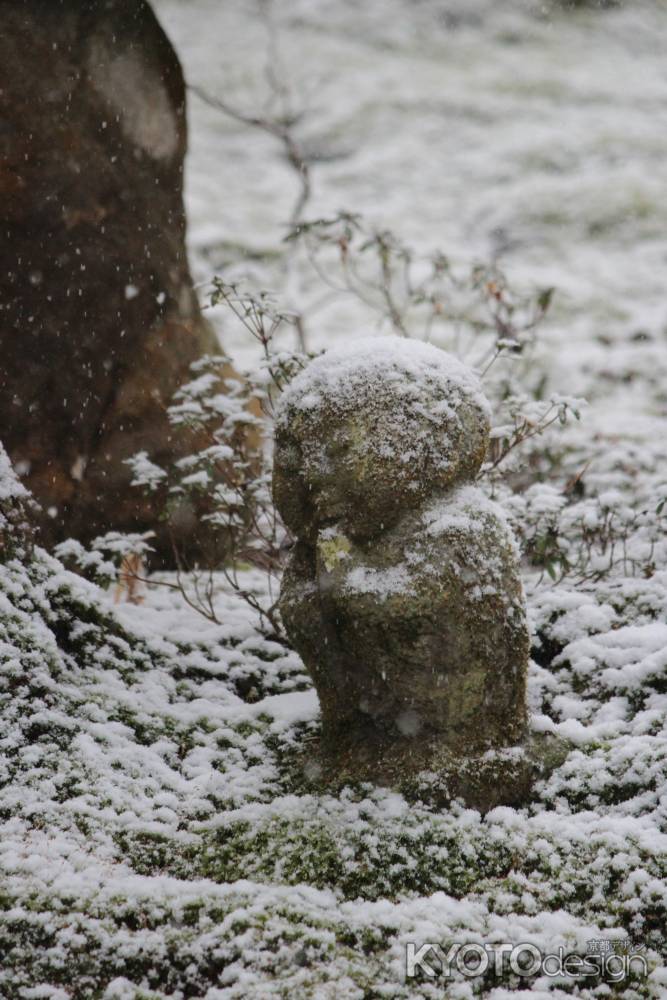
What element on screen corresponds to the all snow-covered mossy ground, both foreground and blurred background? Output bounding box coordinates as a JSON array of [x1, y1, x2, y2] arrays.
[[0, 0, 667, 1000]]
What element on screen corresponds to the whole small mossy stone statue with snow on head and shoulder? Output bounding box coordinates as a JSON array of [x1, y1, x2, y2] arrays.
[[273, 338, 568, 809]]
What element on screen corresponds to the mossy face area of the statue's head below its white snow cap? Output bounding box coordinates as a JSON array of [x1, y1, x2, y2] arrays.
[[274, 384, 488, 540]]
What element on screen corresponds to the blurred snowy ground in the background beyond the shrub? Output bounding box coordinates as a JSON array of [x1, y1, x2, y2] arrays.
[[157, 0, 667, 386]]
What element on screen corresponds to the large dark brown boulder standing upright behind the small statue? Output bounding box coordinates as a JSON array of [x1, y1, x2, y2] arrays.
[[0, 0, 215, 556]]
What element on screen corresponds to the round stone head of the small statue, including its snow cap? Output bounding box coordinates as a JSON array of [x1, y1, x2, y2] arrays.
[[274, 338, 489, 539]]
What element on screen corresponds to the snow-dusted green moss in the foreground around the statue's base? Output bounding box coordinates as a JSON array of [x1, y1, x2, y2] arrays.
[[0, 440, 667, 1000]]
